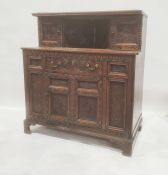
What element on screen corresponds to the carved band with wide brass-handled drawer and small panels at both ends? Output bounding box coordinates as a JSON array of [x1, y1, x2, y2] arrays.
[[25, 51, 134, 77]]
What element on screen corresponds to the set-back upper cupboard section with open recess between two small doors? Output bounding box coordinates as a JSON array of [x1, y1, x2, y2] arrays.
[[33, 11, 144, 50]]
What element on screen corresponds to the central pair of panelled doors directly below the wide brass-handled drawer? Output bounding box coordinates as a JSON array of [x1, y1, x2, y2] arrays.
[[46, 73, 102, 127]]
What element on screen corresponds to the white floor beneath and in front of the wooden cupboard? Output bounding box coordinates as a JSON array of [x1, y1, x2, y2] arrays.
[[0, 109, 168, 175]]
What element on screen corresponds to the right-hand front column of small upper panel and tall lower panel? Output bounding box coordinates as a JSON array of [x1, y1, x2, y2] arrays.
[[106, 61, 132, 135]]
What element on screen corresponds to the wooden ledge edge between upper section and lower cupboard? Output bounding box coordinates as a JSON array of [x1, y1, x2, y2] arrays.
[[22, 47, 139, 55]]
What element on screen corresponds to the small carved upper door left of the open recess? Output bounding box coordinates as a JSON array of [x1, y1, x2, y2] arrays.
[[40, 22, 63, 47]]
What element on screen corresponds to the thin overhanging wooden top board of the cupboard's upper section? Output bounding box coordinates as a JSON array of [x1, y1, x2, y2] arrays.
[[32, 10, 147, 16]]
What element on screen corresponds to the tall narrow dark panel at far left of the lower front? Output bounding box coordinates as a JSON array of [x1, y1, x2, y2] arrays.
[[29, 71, 46, 119]]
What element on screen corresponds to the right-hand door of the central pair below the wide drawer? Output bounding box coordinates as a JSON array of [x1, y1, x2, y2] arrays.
[[75, 77, 102, 127]]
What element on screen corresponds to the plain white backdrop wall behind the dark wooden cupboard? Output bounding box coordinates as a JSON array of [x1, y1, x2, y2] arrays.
[[0, 0, 168, 114]]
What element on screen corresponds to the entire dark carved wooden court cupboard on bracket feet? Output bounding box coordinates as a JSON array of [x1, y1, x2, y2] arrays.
[[23, 11, 146, 155]]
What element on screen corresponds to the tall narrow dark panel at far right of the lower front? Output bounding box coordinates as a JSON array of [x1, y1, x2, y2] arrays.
[[106, 78, 128, 133]]
